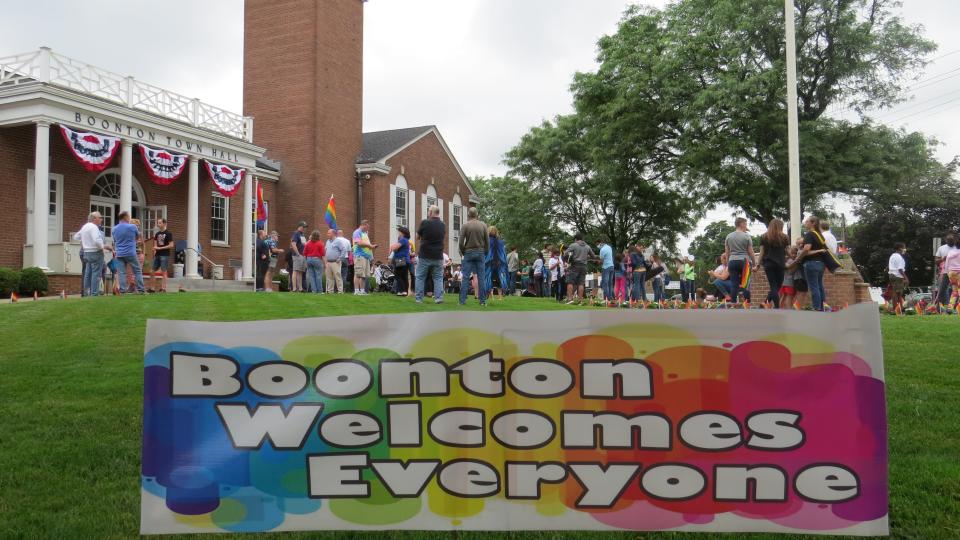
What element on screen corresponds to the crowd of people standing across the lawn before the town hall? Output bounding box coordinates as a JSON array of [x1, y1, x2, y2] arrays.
[[74, 206, 960, 311]]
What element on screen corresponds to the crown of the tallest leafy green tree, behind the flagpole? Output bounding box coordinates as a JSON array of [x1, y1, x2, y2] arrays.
[[573, 0, 935, 222]]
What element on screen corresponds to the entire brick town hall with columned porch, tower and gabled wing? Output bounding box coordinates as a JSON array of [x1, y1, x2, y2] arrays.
[[0, 0, 477, 293]]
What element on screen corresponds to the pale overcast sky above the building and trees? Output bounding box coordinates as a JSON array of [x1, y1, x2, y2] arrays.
[[0, 0, 960, 249]]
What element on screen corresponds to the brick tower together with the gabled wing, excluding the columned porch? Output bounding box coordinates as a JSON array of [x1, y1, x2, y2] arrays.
[[243, 0, 477, 260]]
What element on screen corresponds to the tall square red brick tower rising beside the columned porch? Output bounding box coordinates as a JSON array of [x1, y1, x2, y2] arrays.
[[243, 0, 363, 237]]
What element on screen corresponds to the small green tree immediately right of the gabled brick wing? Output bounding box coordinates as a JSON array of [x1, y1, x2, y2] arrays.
[[471, 176, 567, 257]]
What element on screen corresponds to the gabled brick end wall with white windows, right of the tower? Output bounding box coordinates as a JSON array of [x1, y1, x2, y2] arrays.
[[363, 134, 470, 260]]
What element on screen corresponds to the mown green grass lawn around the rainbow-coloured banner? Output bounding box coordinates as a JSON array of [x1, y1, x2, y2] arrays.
[[0, 293, 960, 540]]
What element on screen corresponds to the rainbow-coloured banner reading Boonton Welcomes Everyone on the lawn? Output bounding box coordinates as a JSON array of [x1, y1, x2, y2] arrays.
[[141, 304, 888, 535]]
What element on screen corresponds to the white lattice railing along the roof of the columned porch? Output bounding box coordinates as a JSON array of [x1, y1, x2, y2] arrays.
[[0, 47, 253, 141]]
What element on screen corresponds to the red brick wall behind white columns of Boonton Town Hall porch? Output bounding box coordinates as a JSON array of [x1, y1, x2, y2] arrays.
[[0, 126, 276, 276]]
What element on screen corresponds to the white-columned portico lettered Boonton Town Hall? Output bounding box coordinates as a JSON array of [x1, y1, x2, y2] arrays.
[[0, 48, 279, 286]]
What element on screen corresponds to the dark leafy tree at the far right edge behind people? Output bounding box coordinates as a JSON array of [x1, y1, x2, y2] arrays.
[[848, 161, 960, 286]]
